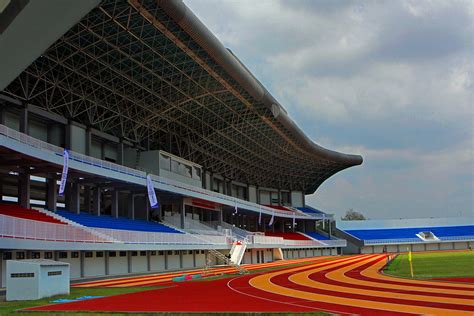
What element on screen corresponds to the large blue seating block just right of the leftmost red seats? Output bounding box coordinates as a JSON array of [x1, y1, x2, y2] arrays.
[[57, 211, 182, 234]]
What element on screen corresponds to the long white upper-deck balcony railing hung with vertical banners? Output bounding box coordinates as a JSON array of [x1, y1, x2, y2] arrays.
[[0, 124, 311, 218]]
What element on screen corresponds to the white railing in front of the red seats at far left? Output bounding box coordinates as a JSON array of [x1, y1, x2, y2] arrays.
[[0, 215, 110, 243]]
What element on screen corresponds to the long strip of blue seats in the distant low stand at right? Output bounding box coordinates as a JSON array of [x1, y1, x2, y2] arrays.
[[345, 225, 474, 240]]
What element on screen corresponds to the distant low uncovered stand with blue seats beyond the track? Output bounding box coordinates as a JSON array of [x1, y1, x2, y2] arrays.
[[335, 217, 474, 253]]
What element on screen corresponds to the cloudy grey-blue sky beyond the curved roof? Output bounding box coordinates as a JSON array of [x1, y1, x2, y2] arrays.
[[185, 0, 474, 219]]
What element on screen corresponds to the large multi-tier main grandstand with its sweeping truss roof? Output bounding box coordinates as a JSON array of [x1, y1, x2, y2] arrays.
[[0, 0, 362, 286]]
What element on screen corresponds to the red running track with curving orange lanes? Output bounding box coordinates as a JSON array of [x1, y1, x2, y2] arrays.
[[26, 255, 474, 316]]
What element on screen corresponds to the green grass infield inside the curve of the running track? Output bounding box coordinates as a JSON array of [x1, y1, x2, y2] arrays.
[[384, 251, 474, 279]]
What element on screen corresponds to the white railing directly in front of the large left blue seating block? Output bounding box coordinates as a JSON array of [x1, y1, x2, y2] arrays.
[[95, 228, 228, 247]]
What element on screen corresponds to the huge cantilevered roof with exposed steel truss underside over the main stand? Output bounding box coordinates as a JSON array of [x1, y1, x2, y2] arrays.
[[3, 0, 362, 193]]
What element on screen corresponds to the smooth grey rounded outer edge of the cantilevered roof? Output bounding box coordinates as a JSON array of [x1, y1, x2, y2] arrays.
[[156, 0, 363, 166]]
